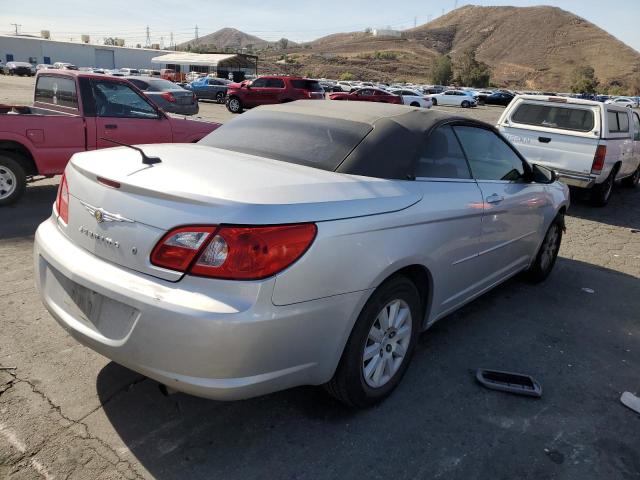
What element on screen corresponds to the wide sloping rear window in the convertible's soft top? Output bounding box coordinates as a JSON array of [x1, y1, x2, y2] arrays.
[[199, 110, 371, 171]]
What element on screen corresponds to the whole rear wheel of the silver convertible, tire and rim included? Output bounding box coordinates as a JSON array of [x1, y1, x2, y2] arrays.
[[325, 276, 421, 407]]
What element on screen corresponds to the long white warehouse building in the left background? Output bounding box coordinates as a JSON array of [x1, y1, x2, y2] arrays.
[[0, 35, 169, 69]]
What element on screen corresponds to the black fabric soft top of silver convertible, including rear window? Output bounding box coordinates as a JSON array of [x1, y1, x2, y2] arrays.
[[200, 100, 493, 179]]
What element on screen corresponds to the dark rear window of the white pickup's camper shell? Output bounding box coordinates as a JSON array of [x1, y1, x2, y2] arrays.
[[511, 103, 595, 132]]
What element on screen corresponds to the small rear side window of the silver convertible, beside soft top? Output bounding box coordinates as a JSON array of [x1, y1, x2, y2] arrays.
[[416, 126, 471, 179]]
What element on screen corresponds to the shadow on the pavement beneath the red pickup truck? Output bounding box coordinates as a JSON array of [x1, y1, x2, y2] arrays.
[[0, 181, 58, 239]]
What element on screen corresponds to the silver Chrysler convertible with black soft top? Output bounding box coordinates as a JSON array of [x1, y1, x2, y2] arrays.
[[35, 101, 569, 407]]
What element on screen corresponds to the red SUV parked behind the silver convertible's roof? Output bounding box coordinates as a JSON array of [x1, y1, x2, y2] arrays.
[[227, 77, 325, 113]]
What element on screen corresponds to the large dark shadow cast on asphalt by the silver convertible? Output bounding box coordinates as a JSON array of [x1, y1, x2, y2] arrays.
[[97, 258, 640, 480]]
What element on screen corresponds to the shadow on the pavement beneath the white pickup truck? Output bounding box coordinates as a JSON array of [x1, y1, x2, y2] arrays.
[[568, 185, 640, 230]]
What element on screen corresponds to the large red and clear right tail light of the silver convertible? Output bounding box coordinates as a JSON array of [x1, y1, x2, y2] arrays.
[[151, 223, 317, 280]]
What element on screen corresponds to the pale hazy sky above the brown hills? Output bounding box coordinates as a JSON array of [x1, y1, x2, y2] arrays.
[[0, 0, 640, 50]]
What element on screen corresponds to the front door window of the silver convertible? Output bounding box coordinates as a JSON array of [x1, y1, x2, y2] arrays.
[[453, 126, 525, 182]]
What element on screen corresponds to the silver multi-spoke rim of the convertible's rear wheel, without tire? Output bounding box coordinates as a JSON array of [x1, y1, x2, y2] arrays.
[[362, 299, 412, 388]]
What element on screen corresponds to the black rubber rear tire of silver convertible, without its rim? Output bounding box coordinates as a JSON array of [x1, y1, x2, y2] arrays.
[[325, 275, 422, 408]]
